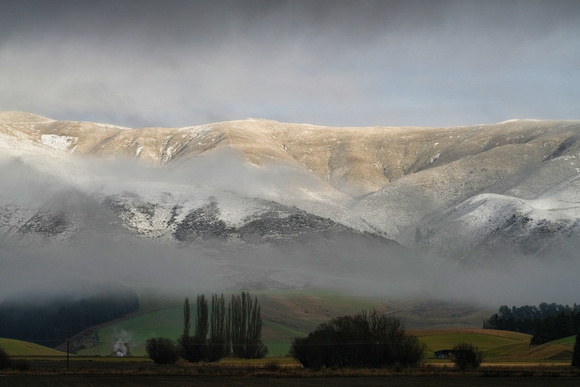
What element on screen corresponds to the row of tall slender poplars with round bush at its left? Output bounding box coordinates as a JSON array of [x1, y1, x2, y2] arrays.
[[147, 292, 268, 362]]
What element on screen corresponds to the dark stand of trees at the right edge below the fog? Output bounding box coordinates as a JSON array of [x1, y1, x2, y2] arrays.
[[483, 302, 580, 345]]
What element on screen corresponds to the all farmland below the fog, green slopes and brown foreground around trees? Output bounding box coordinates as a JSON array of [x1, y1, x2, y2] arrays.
[[0, 291, 580, 387]]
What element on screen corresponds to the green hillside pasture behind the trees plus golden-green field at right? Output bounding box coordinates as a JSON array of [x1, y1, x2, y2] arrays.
[[10, 289, 574, 362]]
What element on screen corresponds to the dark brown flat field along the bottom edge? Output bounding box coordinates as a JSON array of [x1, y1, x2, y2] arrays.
[[0, 358, 580, 387]]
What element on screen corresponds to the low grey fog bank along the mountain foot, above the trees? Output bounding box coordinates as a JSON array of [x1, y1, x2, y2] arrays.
[[0, 232, 580, 307]]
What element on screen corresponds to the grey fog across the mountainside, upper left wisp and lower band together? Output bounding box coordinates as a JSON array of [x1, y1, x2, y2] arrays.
[[0, 152, 580, 306]]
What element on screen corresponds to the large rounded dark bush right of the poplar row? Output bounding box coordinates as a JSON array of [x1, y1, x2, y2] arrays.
[[290, 310, 424, 368]]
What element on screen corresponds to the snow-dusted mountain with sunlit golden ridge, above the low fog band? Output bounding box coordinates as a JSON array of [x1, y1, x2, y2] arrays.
[[0, 112, 580, 298]]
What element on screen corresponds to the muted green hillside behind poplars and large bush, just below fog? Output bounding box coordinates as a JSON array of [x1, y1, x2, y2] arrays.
[[78, 289, 489, 356]]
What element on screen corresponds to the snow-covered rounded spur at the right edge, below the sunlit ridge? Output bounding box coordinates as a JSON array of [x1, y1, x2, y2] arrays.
[[415, 194, 580, 264]]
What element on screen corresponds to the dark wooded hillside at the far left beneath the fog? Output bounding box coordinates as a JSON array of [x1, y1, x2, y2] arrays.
[[0, 286, 139, 347]]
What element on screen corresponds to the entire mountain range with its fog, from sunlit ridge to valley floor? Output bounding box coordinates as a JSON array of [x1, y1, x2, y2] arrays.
[[0, 111, 580, 314]]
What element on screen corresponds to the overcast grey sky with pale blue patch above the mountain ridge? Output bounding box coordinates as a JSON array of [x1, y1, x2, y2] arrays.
[[0, 0, 580, 127]]
